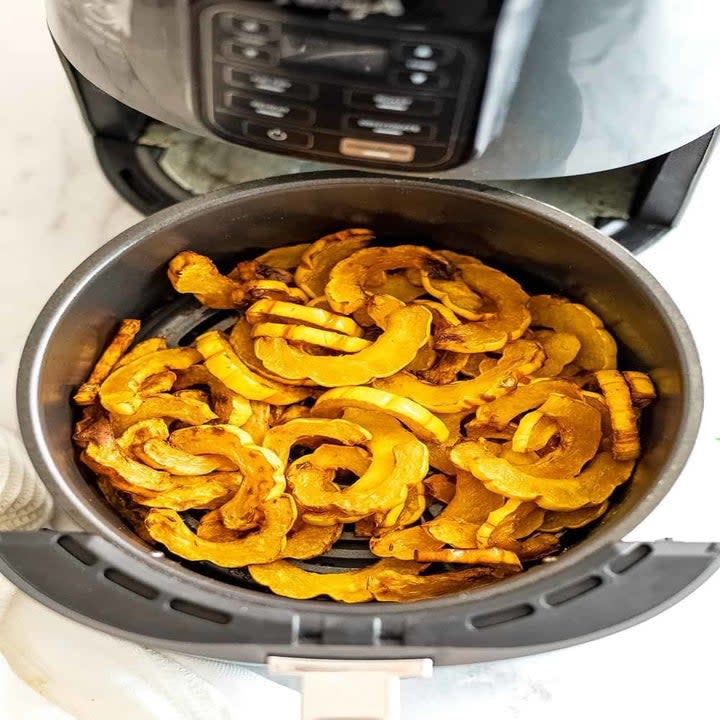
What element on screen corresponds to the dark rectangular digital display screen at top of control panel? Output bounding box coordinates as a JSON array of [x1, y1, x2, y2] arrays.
[[280, 33, 389, 75]]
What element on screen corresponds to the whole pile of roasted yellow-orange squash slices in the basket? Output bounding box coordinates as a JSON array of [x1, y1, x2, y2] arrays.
[[74, 229, 655, 602]]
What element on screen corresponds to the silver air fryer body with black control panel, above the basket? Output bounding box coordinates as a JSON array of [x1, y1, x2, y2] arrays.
[[48, 0, 720, 180]]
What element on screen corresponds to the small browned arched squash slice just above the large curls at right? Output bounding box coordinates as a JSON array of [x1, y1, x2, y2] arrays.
[[466, 378, 582, 437]]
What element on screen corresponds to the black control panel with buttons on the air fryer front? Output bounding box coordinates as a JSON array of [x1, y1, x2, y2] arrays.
[[198, 3, 486, 171]]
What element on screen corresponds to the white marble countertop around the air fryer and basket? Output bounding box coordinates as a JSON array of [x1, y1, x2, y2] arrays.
[[0, 0, 720, 720]]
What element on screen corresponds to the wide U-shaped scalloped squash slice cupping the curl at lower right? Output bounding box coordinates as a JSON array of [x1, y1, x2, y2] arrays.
[[450, 440, 634, 510]]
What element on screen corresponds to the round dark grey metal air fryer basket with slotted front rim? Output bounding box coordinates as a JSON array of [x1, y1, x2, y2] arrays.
[[0, 173, 719, 664]]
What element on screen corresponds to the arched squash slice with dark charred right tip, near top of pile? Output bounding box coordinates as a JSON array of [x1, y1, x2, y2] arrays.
[[325, 245, 451, 315]]
